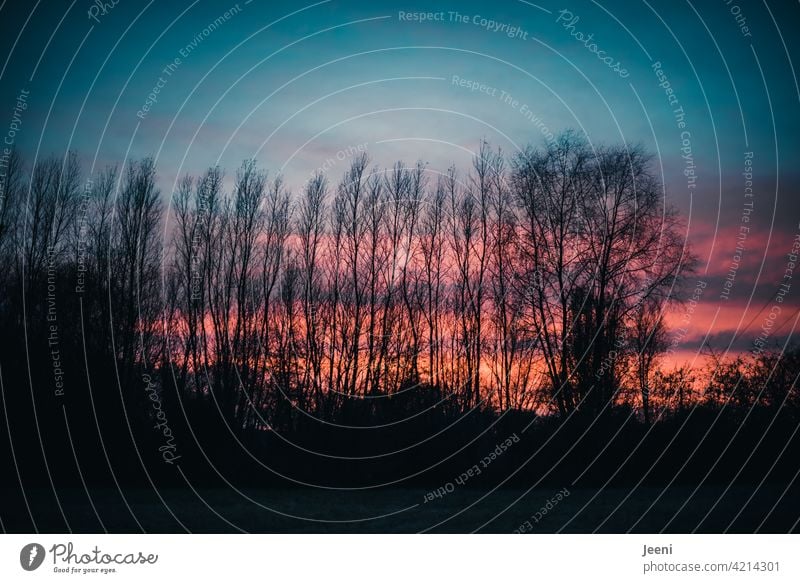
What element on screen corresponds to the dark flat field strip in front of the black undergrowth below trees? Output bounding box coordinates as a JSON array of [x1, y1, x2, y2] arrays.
[[0, 485, 800, 533]]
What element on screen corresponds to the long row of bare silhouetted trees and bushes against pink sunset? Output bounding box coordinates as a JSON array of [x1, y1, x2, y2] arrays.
[[0, 132, 800, 496]]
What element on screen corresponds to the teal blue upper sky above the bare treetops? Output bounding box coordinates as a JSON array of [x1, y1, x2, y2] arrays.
[[2, 0, 798, 182]]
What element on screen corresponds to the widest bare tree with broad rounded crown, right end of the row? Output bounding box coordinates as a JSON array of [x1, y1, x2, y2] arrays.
[[515, 133, 685, 414]]
